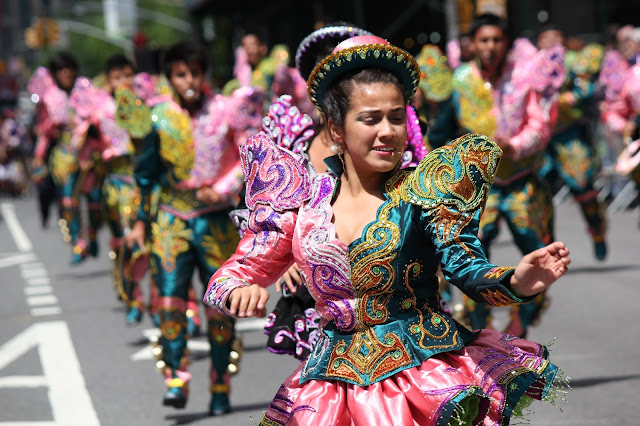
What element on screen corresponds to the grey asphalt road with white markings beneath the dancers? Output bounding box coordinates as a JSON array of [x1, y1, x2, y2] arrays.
[[0, 197, 640, 426]]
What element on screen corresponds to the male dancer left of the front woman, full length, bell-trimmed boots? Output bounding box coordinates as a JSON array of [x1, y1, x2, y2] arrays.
[[127, 42, 264, 415]]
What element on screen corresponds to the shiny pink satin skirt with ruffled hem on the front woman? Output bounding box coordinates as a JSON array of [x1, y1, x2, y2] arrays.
[[260, 330, 559, 426]]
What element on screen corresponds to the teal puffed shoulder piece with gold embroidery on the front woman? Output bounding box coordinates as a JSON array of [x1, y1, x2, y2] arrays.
[[400, 133, 502, 212]]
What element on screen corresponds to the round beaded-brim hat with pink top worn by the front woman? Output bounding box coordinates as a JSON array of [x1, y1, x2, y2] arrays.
[[307, 35, 420, 109]]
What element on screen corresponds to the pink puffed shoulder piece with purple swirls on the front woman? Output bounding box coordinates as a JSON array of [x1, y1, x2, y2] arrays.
[[240, 132, 311, 212]]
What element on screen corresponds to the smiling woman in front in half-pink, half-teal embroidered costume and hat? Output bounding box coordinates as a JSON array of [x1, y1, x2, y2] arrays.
[[205, 36, 570, 425]]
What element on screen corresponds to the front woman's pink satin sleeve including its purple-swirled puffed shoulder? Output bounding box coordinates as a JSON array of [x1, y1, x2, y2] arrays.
[[204, 132, 311, 314]]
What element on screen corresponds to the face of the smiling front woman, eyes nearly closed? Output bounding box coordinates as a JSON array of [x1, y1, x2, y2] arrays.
[[334, 83, 407, 173]]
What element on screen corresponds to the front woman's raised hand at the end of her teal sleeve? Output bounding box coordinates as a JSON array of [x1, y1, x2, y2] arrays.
[[511, 242, 571, 297]]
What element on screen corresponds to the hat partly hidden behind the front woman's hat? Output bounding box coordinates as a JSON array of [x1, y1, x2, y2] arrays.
[[296, 25, 373, 81]]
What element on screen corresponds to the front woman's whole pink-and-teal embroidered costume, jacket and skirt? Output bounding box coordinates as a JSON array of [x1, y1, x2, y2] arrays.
[[205, 133, 558, 425]]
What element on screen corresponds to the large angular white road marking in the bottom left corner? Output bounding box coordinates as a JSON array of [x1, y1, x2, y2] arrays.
[[0, 321, 100, 426]]
